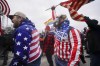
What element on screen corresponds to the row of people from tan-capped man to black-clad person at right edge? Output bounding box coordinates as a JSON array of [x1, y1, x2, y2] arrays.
[[0, 12, 100, 66]]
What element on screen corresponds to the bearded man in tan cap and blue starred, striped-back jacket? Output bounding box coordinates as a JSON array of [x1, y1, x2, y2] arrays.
[[9, 12, 42, 66]]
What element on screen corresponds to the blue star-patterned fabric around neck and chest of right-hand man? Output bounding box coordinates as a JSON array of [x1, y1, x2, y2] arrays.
[[55, 20, 69, 41]]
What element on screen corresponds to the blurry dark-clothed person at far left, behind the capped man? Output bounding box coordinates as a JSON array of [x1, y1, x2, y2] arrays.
[[0, 27, 13, 66]]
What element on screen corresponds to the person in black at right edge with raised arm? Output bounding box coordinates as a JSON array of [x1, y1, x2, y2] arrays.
[[84, 16, 100, 66]]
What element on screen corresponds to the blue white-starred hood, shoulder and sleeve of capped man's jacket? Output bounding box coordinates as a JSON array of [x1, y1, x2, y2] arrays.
[[9, 18, 35, 66]]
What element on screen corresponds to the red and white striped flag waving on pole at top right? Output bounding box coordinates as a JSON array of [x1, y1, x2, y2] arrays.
[[60, 0, 94, 21]]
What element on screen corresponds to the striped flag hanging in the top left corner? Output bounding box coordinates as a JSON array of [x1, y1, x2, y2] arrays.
[[0, 0, 10, 35]]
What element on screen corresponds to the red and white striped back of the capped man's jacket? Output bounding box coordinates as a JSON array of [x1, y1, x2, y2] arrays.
[[29, 30, 42, 63]]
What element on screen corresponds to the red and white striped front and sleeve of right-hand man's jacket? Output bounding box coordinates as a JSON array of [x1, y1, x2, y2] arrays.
[[54, 29, 82, 66]]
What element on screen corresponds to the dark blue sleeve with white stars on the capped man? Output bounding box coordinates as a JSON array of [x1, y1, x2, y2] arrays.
[[10, 29, 31, 66]]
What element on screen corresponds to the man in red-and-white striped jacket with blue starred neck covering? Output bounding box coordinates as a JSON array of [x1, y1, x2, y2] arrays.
[[54, 15, 82, 66]]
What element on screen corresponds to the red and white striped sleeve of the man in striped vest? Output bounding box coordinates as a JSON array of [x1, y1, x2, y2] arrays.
[[68, 29, 82, 66]]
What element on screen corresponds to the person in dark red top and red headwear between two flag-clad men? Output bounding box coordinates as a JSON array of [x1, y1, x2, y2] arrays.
[[43, 26, 54, 66]]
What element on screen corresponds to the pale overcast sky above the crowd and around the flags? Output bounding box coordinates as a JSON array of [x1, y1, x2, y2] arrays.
[[4, 0, 100, 30]]
